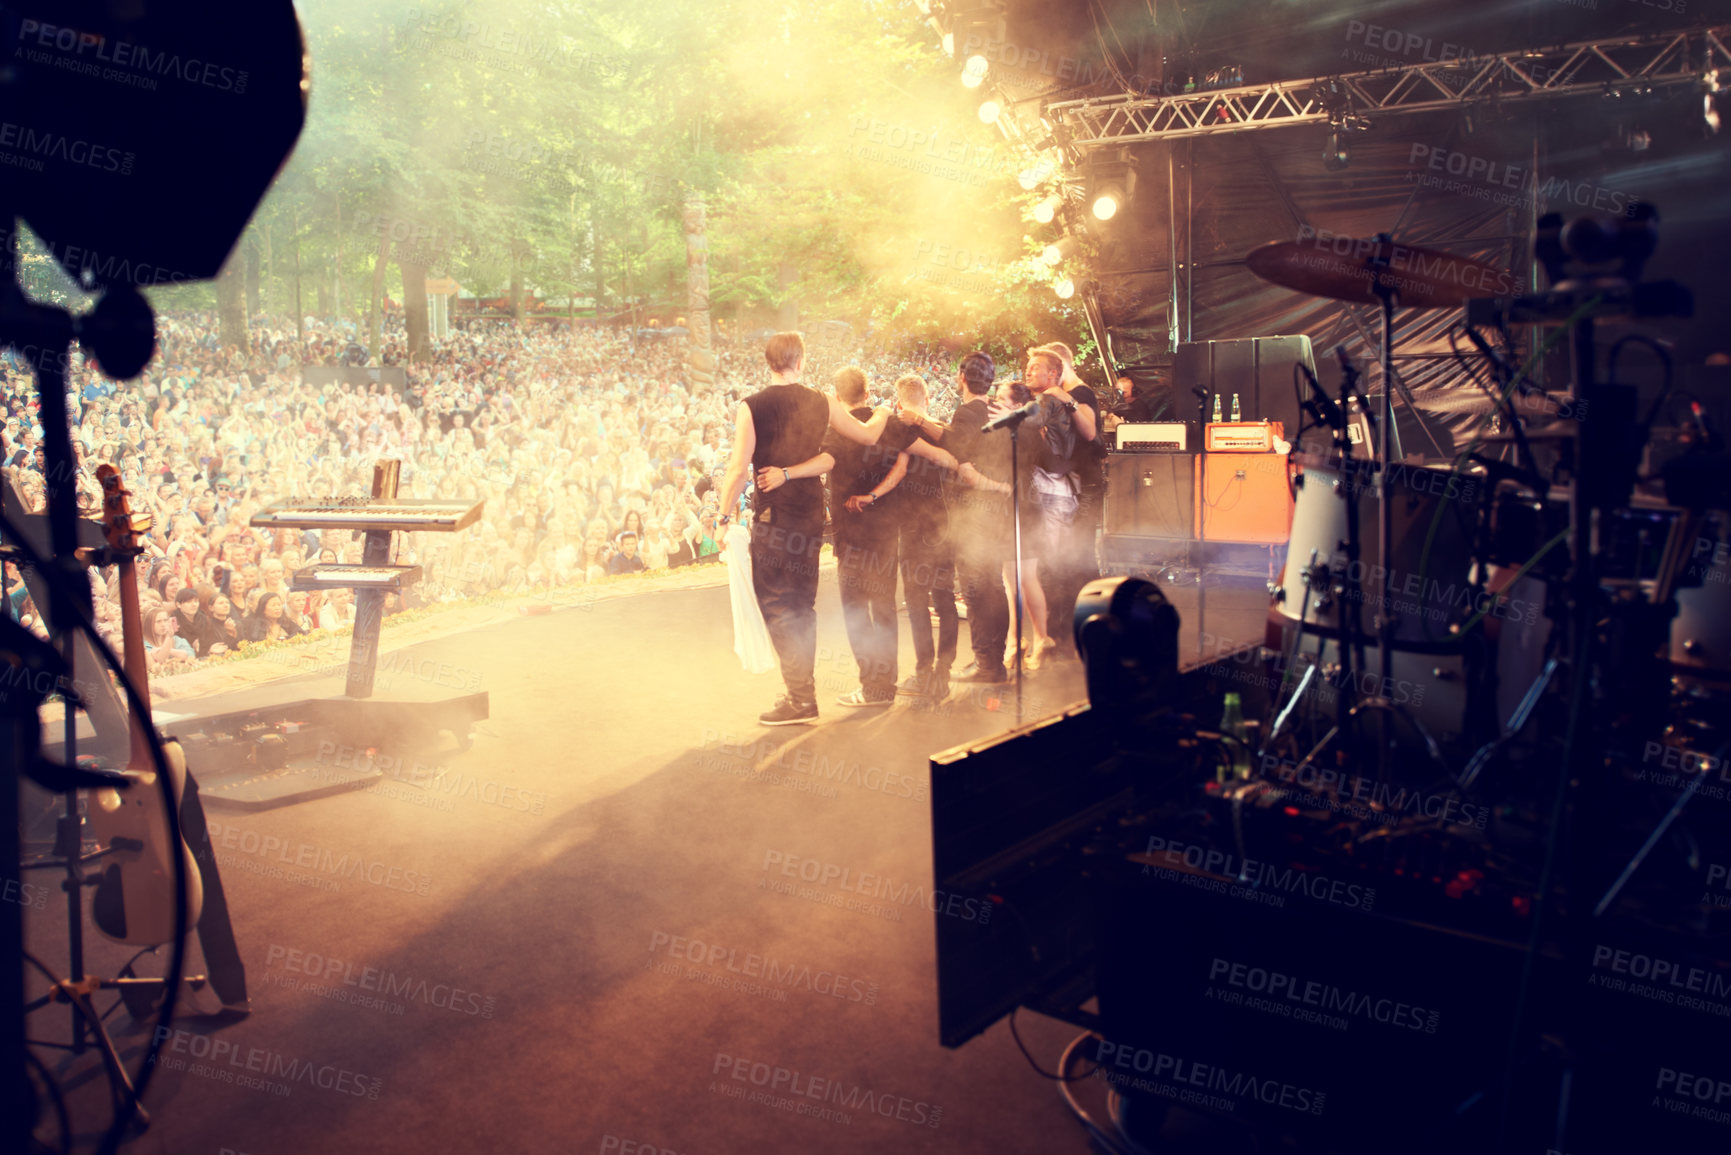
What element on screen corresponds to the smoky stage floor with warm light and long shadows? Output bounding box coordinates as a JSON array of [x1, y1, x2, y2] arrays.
[[28, 582, 1267, 1155]]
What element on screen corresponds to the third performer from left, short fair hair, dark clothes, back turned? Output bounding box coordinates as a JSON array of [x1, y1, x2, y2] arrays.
[[895, 372, 957, 701]]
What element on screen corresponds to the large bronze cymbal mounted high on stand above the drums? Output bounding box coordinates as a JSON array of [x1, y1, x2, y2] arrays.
[[1245, 234, 1520, 308]]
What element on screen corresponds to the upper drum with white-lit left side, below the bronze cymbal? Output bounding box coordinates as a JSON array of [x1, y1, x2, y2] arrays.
[[1274, 457, 1485, 649]]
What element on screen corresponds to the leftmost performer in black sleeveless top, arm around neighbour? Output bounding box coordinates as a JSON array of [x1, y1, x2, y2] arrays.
[[720, 332, 890, 726]]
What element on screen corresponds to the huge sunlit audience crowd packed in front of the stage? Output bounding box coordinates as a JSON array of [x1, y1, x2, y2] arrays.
[[0, 315, 956, 678]]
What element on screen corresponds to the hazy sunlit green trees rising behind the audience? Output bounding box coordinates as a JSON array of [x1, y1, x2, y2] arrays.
[[212, 0, 1085, 350]]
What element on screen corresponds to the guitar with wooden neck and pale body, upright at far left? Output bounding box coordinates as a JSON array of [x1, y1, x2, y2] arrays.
[[85, 462, 204, 945]]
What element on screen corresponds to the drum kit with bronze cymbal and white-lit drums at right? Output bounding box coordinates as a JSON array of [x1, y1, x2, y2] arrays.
[[1246, 220, 1731, 781]]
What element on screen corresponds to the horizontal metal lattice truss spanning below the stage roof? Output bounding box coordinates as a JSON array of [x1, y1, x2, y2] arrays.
[[1046, 24, 1731, 152]]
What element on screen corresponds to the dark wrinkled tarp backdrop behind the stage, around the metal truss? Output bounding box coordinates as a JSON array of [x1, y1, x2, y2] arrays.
[[995, 0, 1731, 457]]
